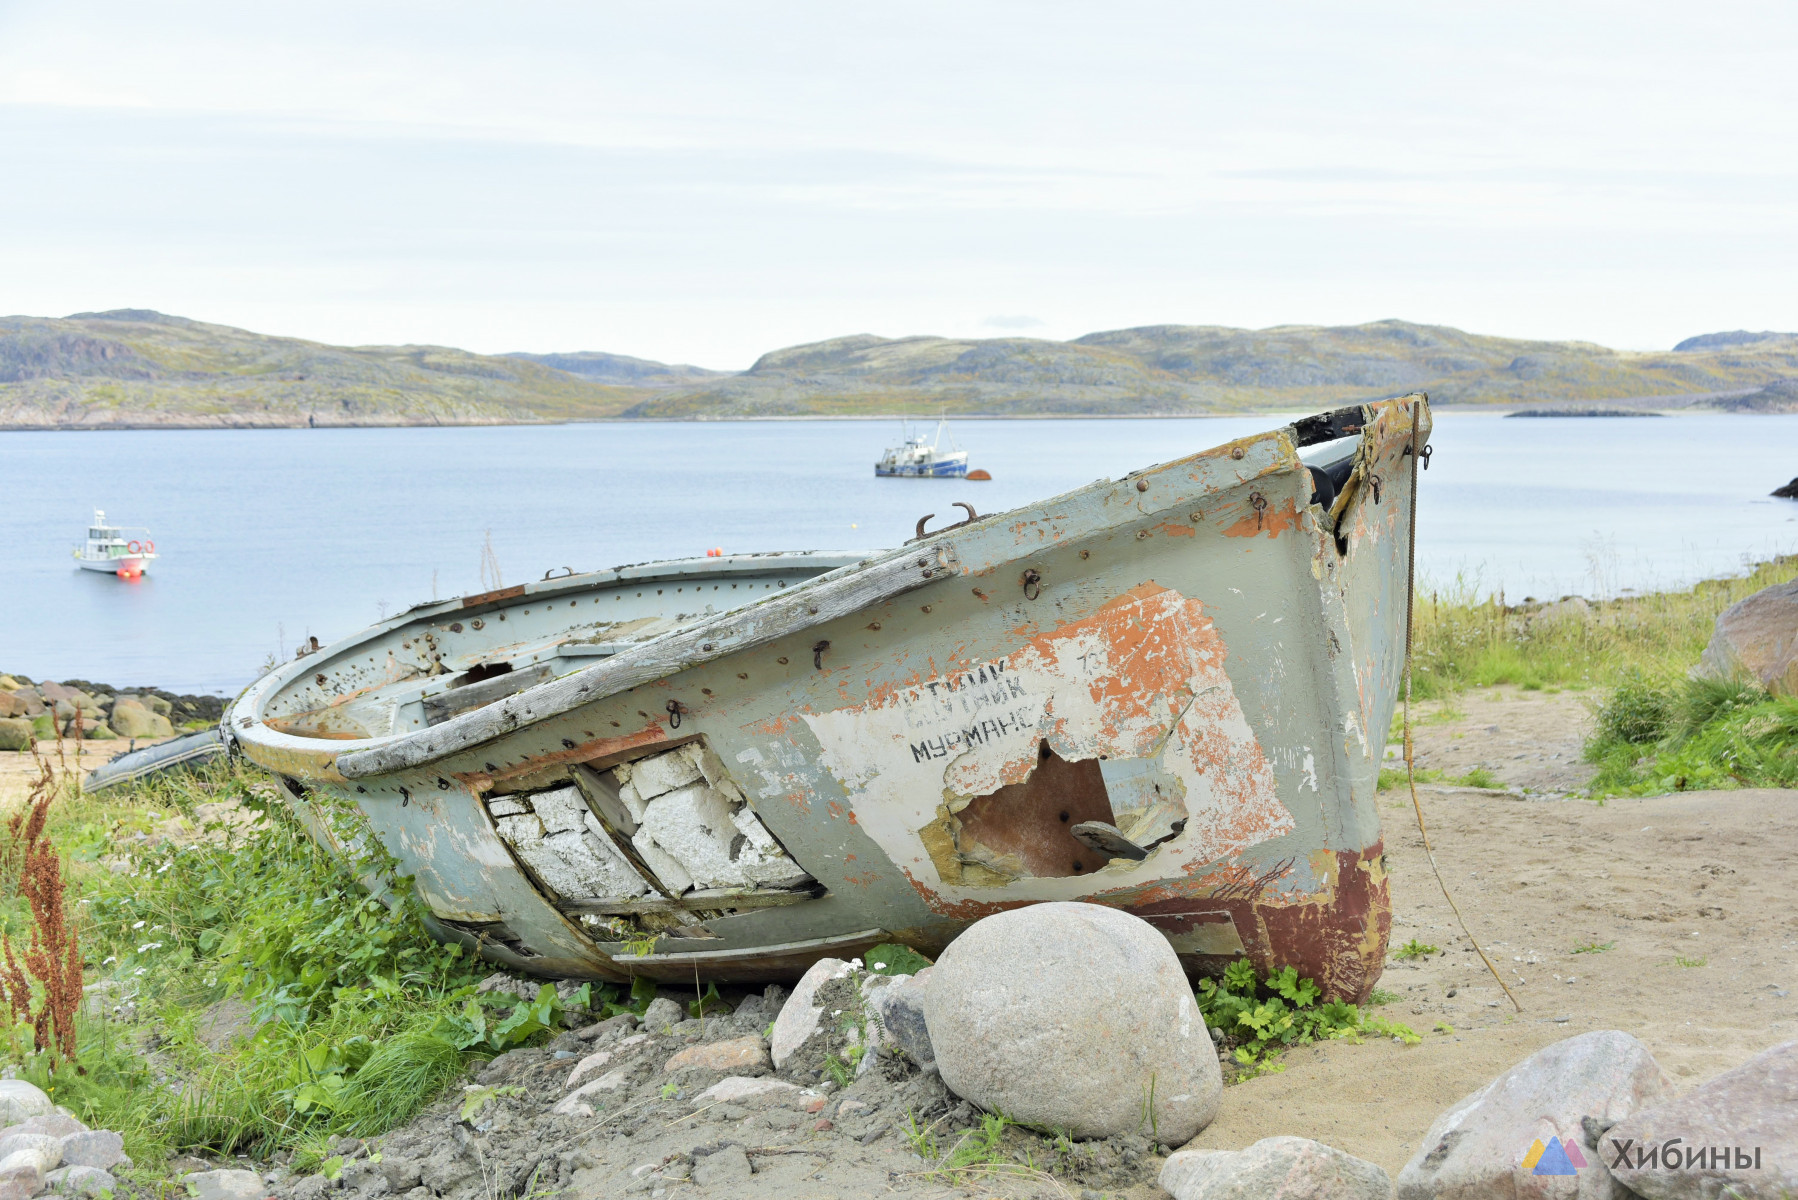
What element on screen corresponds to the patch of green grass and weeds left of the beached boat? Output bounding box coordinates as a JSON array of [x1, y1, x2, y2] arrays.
[[0, 765, 644, 1168]]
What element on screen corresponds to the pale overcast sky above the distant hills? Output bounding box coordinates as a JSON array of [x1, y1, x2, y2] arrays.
[[0, 0, 1798, 367]]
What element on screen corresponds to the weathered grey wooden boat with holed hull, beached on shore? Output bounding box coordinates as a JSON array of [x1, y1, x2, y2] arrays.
[[223, 396, 1429, 997]]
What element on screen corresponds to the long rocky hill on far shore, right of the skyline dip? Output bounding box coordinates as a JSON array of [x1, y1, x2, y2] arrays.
[[628, 320, 1798, 417]]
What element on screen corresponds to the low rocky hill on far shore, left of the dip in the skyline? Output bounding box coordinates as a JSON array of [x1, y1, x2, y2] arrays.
[[0, 308, 642, 428]]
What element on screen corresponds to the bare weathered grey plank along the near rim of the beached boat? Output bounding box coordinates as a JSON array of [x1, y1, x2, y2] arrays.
[[336, 543, 958, 779]]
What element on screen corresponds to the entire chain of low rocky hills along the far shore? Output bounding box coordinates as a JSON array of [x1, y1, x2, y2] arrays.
[[0, 309, 1798, 428]]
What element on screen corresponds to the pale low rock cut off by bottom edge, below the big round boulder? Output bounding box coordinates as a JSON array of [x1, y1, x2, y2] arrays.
[[1162, 1137, 1392, 1200]]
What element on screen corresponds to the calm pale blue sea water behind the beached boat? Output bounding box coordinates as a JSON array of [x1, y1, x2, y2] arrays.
[[0, 414, 1798, 693]]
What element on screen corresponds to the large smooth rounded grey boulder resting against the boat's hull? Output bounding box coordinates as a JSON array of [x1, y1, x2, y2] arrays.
[[924, 901, 1223, 1142]]
